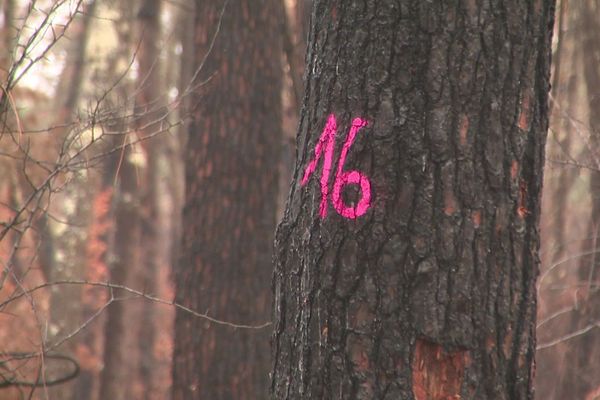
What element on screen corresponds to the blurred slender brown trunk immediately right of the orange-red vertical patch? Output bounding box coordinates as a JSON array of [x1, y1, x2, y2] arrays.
[[99, 2, 144, 400]]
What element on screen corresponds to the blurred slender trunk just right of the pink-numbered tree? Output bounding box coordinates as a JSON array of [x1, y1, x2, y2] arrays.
[[535, 0, 588, 400]]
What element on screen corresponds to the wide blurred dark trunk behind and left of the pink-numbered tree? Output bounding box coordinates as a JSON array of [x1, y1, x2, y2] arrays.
[[173, 0, 283, 400]]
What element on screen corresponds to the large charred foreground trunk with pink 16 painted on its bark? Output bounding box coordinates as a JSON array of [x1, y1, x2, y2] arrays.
[[271, 0, 554, 400]]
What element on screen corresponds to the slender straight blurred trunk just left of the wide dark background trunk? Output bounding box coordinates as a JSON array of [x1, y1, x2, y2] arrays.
[[135, 0, 164, 400]]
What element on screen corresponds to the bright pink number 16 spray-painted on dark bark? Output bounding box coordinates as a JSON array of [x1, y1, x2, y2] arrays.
[[301, 114, 371, 219]]
